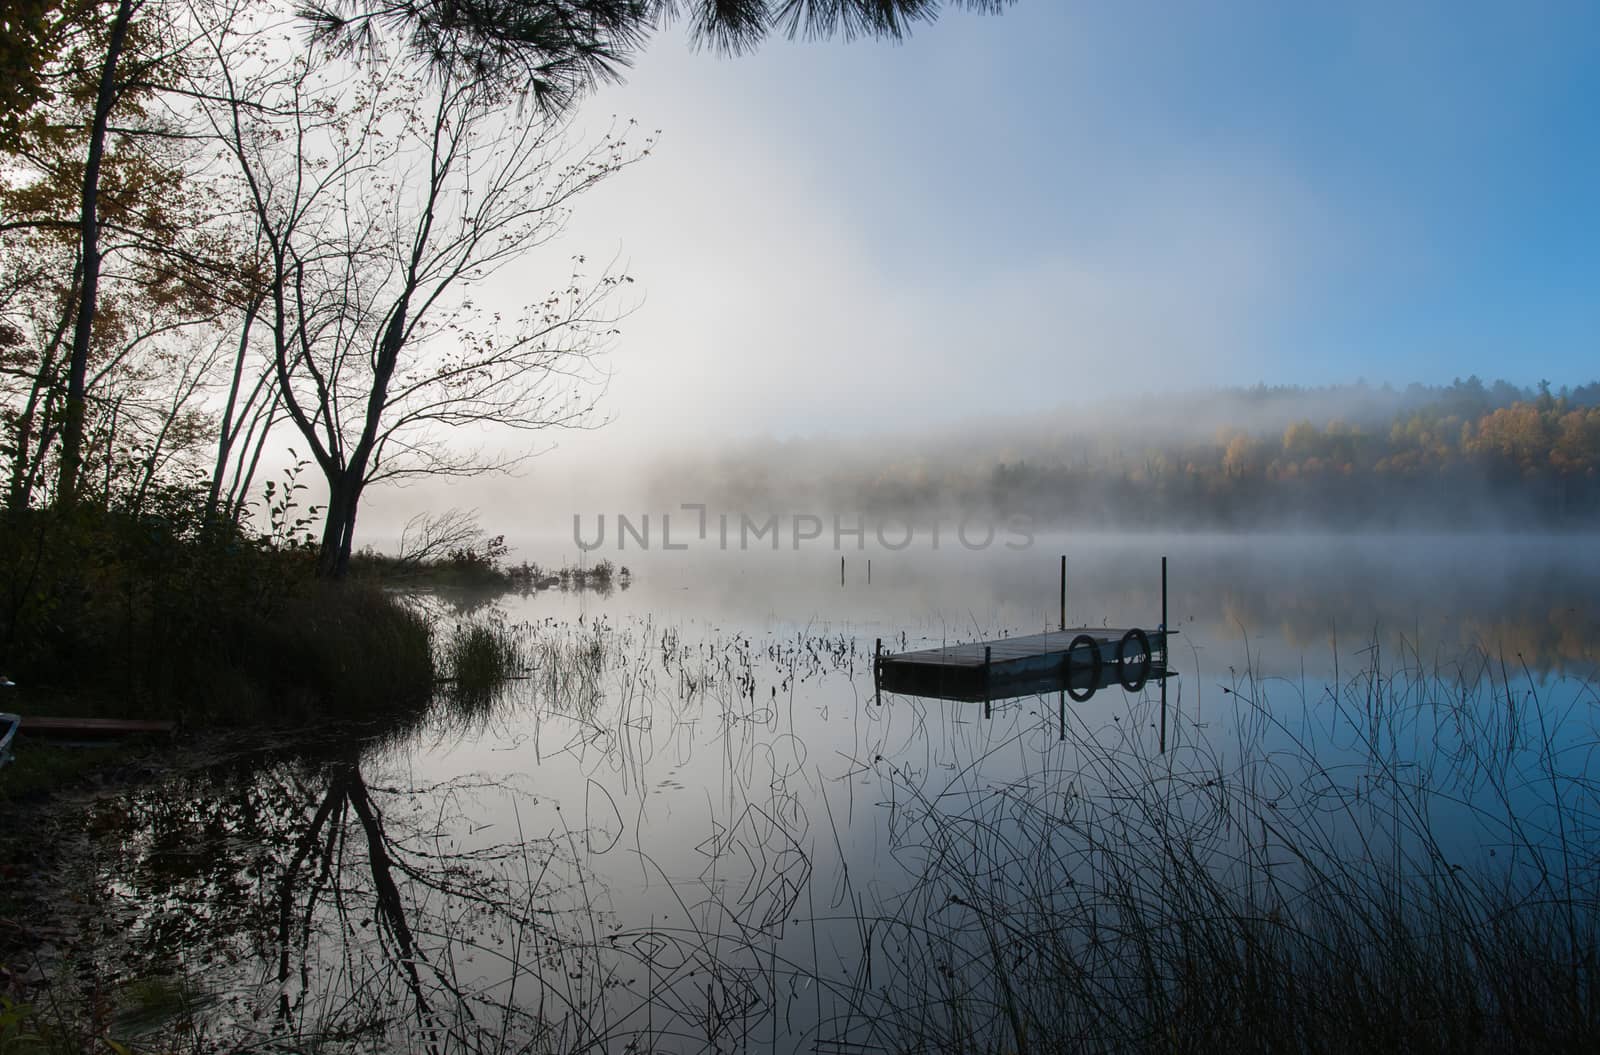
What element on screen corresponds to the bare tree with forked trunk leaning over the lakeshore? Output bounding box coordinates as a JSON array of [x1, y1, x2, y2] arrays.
[[197, 26, 650, 578]]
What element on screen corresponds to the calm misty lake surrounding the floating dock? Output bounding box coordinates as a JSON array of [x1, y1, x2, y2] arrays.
[[34, 536, 1600, 1052]]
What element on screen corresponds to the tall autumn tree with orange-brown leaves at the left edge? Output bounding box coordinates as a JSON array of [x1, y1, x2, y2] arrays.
[[0, 0, 237, 507]]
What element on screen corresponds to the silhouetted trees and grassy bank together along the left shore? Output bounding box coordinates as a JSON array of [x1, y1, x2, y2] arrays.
[[0, 0, 648, 742]]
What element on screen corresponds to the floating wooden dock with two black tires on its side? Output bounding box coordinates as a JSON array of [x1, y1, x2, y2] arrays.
[[875, 626, 1178, 701]]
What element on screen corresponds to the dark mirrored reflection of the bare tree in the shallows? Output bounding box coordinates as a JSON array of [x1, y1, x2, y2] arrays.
[[51, 714, 793, 1052]]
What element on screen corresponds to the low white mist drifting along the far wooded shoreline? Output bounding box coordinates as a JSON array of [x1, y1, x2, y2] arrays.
[[363, 378, 1600, 544]]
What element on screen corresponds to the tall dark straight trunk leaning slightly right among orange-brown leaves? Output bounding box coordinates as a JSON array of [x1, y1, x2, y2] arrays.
[[56, 0, 134, 506]]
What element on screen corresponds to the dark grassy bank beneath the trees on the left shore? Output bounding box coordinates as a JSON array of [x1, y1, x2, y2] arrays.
[[0, 509, 437, 794]]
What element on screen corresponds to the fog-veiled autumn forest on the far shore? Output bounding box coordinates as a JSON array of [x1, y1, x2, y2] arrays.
[[668, 376, 1600, 530]]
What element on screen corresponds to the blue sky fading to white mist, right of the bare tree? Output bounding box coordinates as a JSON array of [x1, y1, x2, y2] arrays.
[[483, 0, 1600, 448]]
